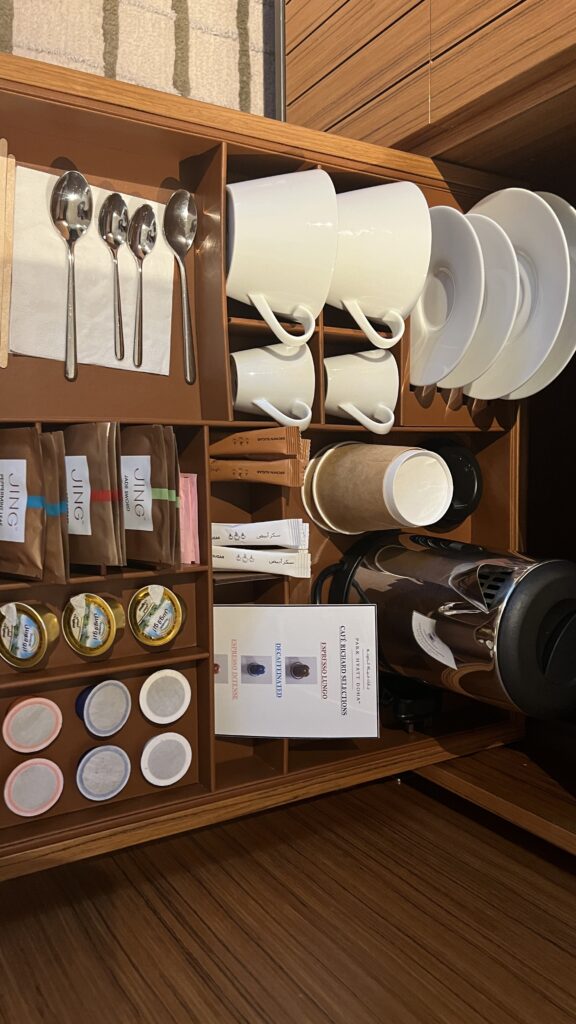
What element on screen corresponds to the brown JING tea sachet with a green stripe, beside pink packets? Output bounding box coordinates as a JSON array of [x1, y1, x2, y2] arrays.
[[120, 424, 171, 565]]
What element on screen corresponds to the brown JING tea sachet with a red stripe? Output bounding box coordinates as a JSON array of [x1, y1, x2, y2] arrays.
[[64, 423, 121, 565]]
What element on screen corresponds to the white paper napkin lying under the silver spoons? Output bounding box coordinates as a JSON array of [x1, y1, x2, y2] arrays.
[[10, 167, 174, 376]]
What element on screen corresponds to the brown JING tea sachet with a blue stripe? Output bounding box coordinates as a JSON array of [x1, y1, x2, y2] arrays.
[[0, 427, 46, 580]]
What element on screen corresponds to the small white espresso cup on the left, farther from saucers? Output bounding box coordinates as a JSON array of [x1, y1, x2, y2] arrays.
[[231, 345, 315, 430]]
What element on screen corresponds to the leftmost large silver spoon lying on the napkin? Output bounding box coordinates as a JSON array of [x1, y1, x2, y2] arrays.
[[50, 171, 92, 381]]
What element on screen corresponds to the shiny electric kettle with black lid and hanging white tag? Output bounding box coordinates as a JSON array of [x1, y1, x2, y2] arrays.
[[315, 532, 576, 718]]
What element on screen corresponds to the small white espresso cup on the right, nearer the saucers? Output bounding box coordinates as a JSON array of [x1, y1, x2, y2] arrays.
[[324, 348, 400, 434]]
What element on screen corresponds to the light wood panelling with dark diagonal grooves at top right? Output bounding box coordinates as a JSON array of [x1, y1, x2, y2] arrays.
[[286, 0, 576, 155]]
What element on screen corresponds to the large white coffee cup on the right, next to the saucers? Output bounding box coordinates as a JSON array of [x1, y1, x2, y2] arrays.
[[327, 181, 431, 348]]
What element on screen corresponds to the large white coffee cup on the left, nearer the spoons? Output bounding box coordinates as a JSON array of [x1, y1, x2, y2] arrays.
[[227, 169, 337, 348]]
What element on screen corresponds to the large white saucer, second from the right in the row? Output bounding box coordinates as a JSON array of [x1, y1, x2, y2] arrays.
[[464, 188, 570, 399]]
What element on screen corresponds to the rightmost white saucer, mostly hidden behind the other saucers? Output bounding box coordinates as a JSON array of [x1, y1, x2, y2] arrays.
[[506, 193, 576, 398]]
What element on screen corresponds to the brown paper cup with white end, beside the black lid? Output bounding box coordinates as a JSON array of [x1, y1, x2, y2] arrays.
[[313, 442, 453, 532]]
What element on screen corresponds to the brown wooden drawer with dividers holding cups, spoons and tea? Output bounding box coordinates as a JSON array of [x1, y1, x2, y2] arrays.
[[0, 55, 523, 878]]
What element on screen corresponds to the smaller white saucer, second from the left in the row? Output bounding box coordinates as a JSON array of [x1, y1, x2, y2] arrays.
[[439, 213, 520, 388]]
